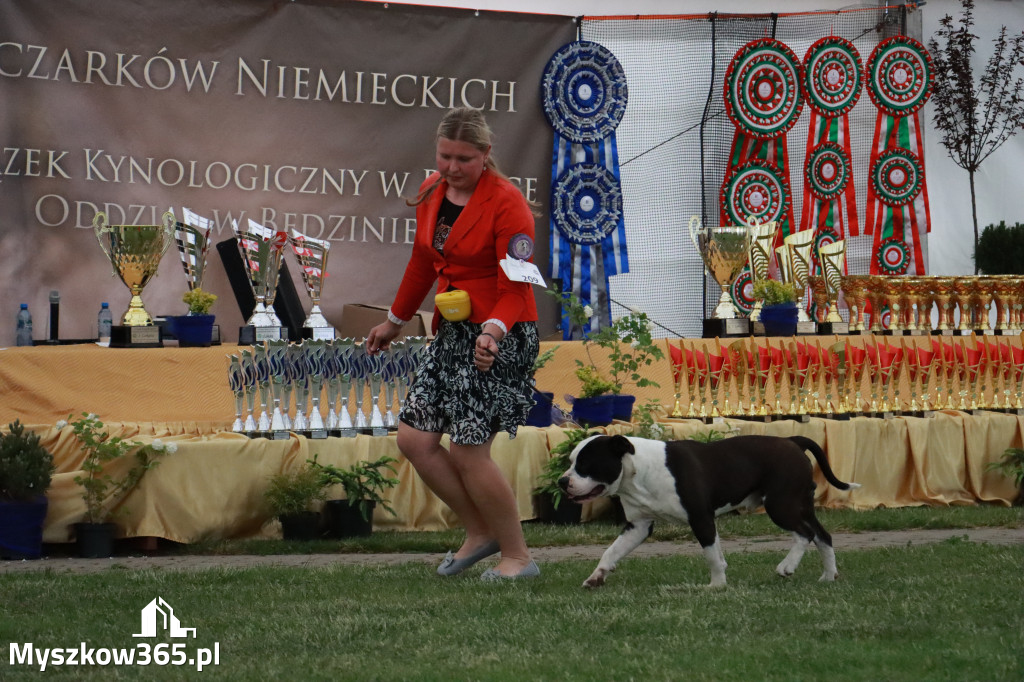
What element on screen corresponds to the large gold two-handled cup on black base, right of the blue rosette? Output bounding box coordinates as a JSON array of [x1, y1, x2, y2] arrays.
[[689, 216, 751, 338]]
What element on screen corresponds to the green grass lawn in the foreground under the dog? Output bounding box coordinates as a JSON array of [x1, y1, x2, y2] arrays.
[[0, 507, 1024, 681]]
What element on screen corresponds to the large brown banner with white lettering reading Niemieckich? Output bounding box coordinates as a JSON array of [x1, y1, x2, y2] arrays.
[[0, 0, 575, 345]]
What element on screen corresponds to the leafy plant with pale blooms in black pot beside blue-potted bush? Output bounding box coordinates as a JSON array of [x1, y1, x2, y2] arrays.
[[66, 413, 171, 559]]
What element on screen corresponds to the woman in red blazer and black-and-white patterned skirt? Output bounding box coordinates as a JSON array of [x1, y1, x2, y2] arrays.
[[366, 109, 540, 580]]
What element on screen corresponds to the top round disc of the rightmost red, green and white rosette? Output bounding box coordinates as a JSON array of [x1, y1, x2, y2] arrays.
[[867, 36, 934, 118]]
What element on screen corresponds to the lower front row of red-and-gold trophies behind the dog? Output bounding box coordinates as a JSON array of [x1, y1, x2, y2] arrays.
[[669, 335, 1024, 422]]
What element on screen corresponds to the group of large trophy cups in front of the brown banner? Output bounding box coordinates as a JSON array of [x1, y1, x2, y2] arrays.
[[92, 208, 336, 347]]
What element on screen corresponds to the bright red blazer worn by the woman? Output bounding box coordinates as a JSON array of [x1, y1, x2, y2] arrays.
[[391, 170, 537, 331]]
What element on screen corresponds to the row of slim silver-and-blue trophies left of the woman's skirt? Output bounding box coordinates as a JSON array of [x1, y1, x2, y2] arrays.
[[227, 337, 426, 439]]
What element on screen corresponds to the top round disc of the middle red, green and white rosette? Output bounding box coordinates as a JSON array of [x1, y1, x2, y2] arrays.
[[804, 36, 863, 119]]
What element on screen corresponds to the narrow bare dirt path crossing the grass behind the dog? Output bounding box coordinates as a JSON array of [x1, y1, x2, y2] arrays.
[[0, 528, 1024, 573]]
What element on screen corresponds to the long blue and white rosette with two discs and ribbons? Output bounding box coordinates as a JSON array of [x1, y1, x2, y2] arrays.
[[541, 40, 629, 339]]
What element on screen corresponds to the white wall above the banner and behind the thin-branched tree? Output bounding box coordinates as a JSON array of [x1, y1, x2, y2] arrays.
[[389, 0, 1024, 274]]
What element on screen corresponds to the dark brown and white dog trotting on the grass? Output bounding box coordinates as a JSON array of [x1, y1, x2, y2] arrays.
[[558, 435, 860, 588]]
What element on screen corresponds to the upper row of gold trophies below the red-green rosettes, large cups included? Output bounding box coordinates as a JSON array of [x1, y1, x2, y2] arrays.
[[689, 216, 1024, 338]]
